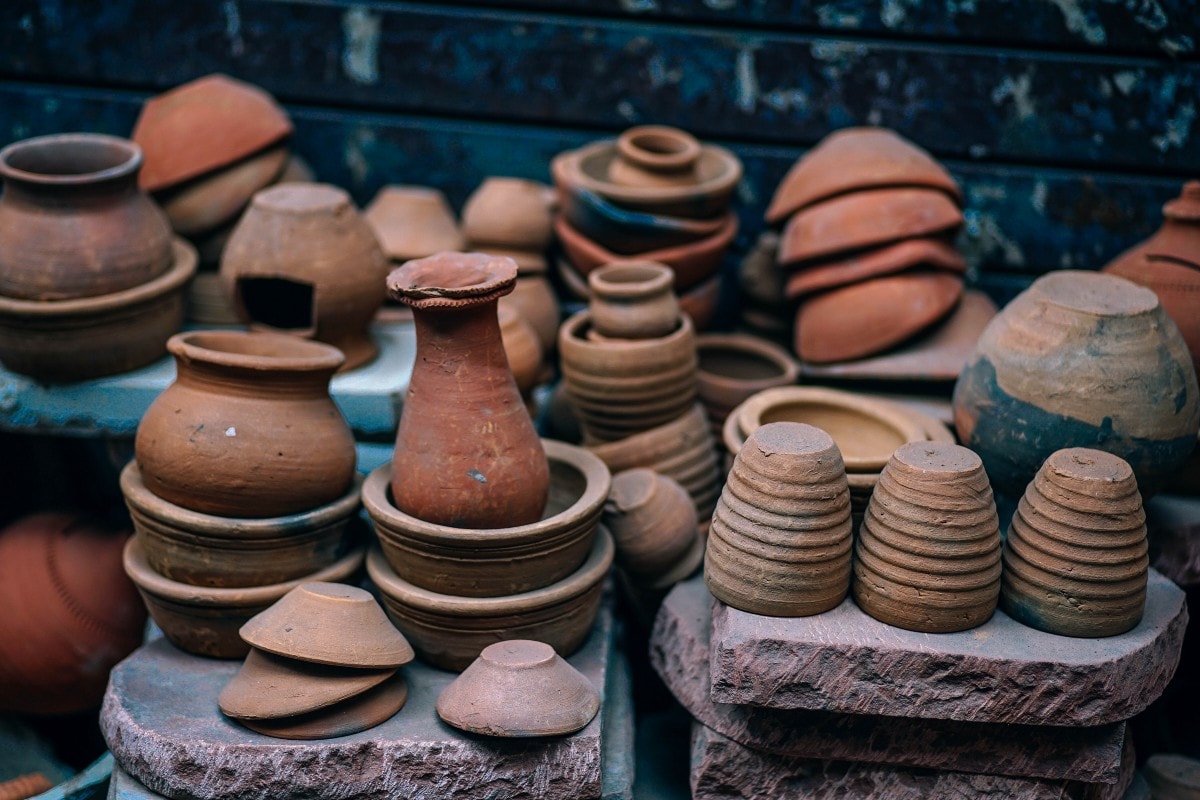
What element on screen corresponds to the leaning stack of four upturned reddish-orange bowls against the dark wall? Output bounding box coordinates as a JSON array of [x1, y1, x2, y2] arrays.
[[767, 128, 966, 363]]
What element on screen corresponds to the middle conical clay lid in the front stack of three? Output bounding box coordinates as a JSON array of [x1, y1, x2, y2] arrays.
[[217, 650, 396, 720]]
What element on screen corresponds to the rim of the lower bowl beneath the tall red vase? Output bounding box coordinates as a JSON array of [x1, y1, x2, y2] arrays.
[[367, 525, 616, 619]]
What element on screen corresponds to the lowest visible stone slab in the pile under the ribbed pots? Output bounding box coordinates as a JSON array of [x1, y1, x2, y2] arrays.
[[691, 722, 1133, 800]]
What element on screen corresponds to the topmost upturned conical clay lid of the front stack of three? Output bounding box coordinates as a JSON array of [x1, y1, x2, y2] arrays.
[[239, 583, 413, 669]]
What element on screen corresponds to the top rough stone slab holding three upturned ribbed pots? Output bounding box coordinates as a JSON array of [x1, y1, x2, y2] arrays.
[[710, 570, 1188, 727]]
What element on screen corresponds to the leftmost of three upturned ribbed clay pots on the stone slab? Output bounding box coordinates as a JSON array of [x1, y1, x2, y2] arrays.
[[704, 422, 853, 616]]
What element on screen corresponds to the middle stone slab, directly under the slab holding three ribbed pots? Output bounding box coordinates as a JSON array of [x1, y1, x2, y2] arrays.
[[650, 577, 1126, 783]]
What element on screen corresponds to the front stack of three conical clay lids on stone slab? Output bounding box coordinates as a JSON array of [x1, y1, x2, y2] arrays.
[[217, 582, 413, 739]]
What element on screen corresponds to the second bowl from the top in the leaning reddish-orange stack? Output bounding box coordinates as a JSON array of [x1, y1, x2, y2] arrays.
[[779, 188, 962, 265]]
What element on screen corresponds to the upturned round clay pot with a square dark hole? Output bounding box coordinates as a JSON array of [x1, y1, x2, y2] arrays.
[[221, 184, 388, 369]]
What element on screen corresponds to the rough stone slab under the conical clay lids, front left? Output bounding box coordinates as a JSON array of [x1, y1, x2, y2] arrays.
[[100, 603, 631, 800]]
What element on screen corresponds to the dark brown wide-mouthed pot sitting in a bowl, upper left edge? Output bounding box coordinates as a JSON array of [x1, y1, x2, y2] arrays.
[[0, 133, 173, 300]]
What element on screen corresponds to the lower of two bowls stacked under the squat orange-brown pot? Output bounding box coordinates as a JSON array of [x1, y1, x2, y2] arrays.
[[125, 536, 365, 658]]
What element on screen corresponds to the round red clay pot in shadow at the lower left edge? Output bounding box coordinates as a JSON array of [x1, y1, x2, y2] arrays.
[[0, 512, 145, 714]]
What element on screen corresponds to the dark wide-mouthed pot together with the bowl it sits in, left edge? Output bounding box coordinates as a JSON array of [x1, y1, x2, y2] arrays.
[[0, 133, 196, 383]]
